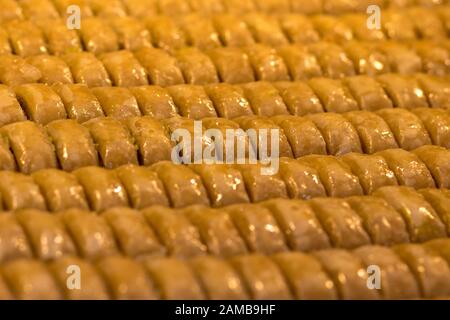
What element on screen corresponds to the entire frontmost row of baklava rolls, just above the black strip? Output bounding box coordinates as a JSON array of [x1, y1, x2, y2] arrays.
[[0, 235, 450, 300]]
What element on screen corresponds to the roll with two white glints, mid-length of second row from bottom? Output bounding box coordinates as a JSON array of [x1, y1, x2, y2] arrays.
[[225, 204, 287, 254]]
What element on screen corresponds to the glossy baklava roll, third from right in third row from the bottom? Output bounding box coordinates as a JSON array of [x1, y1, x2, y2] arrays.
[[340, 152, 397, 194]]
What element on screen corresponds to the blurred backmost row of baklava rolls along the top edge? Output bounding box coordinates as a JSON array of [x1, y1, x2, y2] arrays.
[[0, 0, 447, 23]]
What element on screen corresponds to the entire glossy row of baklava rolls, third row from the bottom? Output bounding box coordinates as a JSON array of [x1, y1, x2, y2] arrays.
[[0, 146, 450, 211]]
